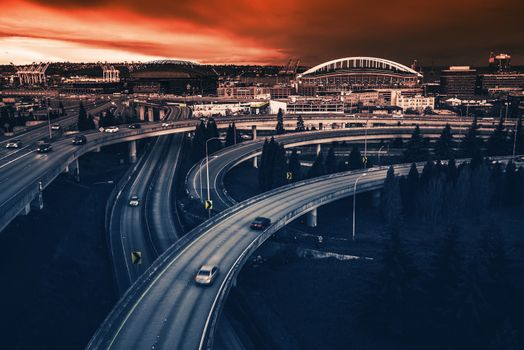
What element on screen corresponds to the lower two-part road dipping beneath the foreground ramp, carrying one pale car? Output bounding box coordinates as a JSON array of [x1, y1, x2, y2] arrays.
[[108, 107, 189, 295]]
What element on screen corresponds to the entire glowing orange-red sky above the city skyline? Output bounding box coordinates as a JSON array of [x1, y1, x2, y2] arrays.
[[0, 0, 524, 65]]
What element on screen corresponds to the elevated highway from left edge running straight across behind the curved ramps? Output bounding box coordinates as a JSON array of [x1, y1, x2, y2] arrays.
[[0, 112, 492, 231]]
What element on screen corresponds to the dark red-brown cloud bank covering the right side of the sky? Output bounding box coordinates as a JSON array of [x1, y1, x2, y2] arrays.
[[9, 0, 524, 64]]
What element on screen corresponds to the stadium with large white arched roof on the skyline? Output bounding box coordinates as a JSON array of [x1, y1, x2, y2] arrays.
[[296, 57, 422, 96]]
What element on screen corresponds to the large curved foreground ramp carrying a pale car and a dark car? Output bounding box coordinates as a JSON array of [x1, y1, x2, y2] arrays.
[[87, 157, 516, 349]]
